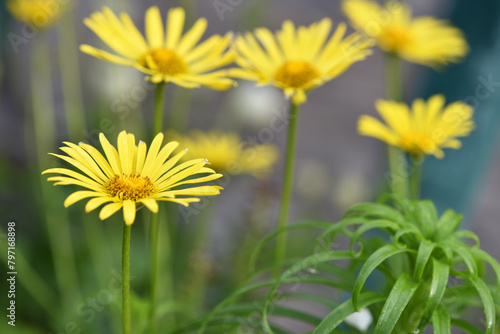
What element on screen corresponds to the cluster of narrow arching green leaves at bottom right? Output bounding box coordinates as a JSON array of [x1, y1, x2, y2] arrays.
[[174, 197, 500, 334]]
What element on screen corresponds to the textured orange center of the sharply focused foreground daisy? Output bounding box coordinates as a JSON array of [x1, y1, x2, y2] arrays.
[[106, 174, 156, 202]]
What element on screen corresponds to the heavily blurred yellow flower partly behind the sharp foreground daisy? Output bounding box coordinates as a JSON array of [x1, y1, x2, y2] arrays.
[[167, 130, 279, 178]]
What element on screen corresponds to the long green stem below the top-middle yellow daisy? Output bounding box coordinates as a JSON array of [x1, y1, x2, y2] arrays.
[[274, 103, 299, 275]]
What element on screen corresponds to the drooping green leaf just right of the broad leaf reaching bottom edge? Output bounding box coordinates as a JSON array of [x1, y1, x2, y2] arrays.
[[418, 258, 450, 331]]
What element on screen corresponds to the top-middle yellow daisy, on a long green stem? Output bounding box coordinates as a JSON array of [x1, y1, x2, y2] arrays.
[[231, 18, 372, 105]]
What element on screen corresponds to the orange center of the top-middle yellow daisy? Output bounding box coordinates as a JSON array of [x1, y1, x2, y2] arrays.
[[274, 61, 320, 88]]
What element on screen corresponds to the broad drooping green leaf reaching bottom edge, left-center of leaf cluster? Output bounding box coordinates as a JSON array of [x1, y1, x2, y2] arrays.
[[374, 273, 420, 334]]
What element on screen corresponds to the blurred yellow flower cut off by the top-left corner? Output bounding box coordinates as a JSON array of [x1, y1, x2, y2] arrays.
[[7, 0, 68, 29]]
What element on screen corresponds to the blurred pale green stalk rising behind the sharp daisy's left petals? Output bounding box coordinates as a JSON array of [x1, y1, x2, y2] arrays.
[[57, 11, 86, 140]]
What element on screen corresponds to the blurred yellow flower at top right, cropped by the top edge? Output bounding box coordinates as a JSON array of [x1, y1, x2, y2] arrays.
[[342, 0, 469, 67]]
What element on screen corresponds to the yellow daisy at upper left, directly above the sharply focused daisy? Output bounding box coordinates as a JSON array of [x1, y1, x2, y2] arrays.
[[80, 6, 235, 90]]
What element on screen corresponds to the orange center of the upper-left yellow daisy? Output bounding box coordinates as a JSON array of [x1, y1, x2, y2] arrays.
[[142, 49, 187, 76]]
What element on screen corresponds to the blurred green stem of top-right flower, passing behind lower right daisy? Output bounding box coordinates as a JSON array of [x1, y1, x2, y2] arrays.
[[386, 54, 409, 196]]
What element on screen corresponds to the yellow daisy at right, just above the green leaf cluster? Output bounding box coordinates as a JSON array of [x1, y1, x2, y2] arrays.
[[358, 95, 474, 159]]
